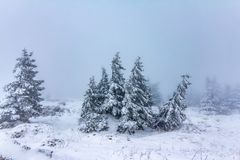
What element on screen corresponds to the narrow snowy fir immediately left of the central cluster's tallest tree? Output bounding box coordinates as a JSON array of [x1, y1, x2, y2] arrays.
[[97, 68, 110, 109]]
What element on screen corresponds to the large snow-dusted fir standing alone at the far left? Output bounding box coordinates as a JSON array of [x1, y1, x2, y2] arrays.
[[3, 49, 44, 122]]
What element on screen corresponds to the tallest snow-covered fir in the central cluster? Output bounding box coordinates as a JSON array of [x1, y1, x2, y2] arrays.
[[103, 53, 125, 118]]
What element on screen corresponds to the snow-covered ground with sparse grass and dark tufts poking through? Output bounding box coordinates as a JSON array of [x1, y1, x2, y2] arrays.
[[0, 101, 240, 160]]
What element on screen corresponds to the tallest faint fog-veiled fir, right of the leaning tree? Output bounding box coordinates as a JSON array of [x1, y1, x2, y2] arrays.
[[200, 78, 222, 114]]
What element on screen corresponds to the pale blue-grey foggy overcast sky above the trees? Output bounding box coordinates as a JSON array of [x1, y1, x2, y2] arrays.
[[0, 0, 240, 99]]
